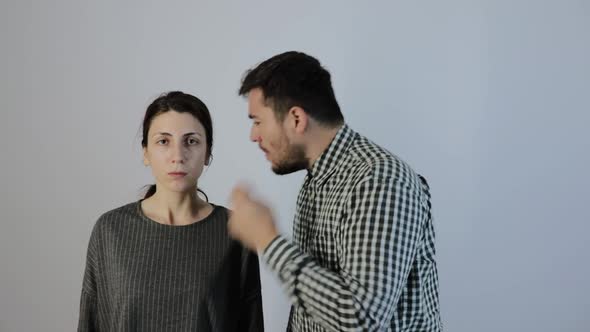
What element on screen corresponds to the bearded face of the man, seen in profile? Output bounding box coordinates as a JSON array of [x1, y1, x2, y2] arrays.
[[248, 88, 308, 175]]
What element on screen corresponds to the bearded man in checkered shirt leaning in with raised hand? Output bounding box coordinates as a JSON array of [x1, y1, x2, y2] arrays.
[[229, 52, 442, 332]]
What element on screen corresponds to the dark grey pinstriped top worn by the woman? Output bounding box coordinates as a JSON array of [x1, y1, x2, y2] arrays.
[[78, 201, 263, 332]]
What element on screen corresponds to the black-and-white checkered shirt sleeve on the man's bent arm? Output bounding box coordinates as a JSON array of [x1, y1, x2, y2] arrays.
[[264, 176, 427, 331]]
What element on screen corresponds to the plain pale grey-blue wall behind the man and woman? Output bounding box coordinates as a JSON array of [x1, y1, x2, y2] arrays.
[[0, 0, 590, 332]]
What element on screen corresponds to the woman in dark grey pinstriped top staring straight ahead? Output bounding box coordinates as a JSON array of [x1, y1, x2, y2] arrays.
[[78, 92, 263, 331]]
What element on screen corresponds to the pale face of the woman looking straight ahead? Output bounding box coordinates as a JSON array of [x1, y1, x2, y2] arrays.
[[143, 110, 208, 193]]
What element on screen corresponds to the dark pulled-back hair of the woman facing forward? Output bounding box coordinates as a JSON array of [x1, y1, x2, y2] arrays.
[[141, 91, 213, 201]]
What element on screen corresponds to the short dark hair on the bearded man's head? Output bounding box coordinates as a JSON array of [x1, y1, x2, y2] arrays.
[[239, 51, 344, 126]]
